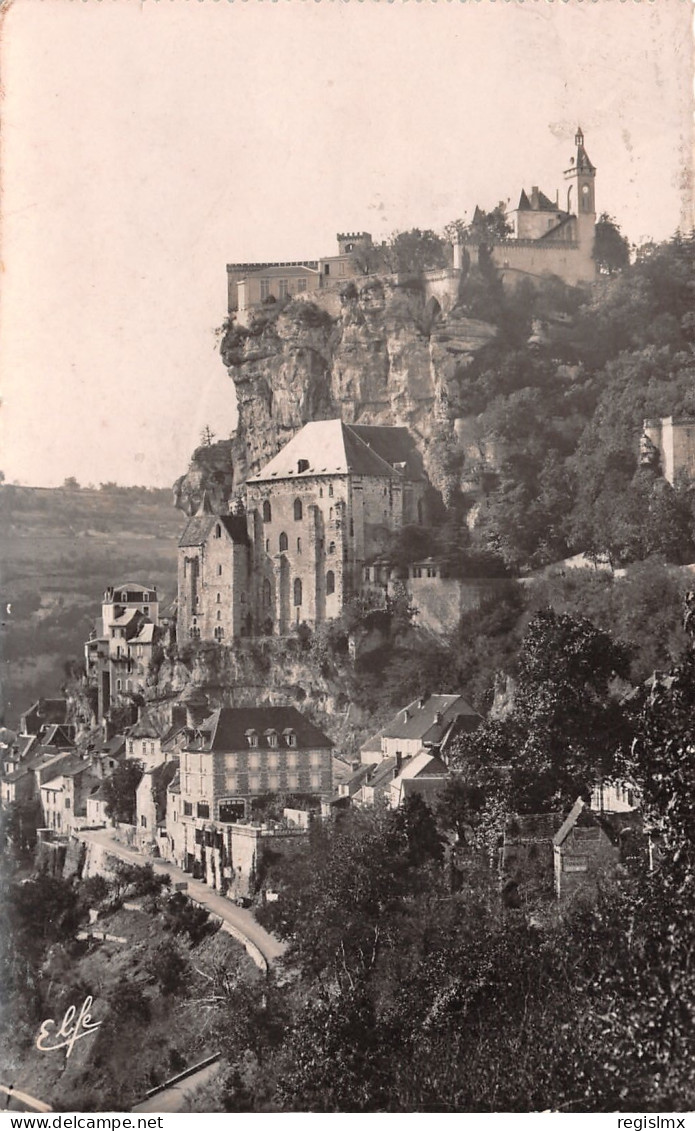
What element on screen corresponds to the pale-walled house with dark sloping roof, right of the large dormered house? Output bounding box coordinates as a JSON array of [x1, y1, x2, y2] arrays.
[[359, 694, 483, 762]]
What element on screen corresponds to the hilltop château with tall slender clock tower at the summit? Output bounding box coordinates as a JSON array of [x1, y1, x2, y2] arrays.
[[454, 128, 597, 286]]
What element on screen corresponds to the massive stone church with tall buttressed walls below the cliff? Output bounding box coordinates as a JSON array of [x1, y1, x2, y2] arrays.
[[177, 420, 427, 645]]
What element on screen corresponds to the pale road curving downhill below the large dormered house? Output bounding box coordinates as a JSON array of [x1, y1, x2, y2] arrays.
[[77, 829, 285, 965]]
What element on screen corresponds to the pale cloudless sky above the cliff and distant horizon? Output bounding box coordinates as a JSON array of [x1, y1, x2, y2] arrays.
[[0, 0, 693, 486]]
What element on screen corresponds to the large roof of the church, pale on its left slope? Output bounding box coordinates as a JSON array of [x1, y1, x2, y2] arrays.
[[247, 420, 411, 483]]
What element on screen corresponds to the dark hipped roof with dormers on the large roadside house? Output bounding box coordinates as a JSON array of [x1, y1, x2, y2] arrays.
[[186, 707, 332, 751]]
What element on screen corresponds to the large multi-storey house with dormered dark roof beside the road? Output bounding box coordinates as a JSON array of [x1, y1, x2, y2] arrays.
[[166, 707, 332, 880]]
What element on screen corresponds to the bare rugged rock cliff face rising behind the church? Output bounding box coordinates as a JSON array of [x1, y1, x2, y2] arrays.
[[175, 278, 496, 512]]
